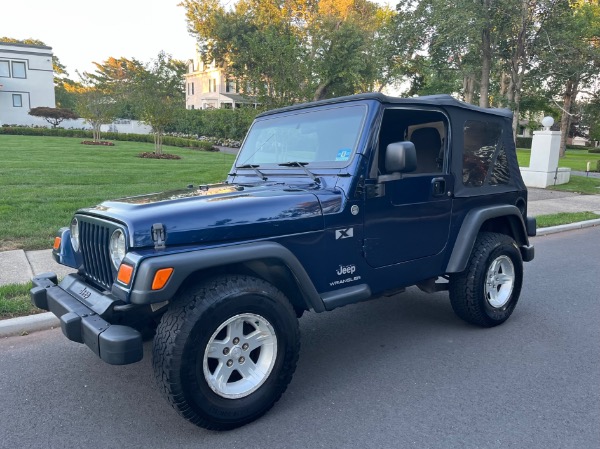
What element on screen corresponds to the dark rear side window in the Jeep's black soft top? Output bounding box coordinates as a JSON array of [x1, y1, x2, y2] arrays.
[[463, 120, 510, 187]]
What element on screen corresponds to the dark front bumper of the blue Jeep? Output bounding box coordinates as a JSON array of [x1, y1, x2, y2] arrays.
[[30, 273, 143, 365]]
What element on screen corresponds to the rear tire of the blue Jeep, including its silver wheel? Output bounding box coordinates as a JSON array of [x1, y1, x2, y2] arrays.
[[450, 232, 523, 327]]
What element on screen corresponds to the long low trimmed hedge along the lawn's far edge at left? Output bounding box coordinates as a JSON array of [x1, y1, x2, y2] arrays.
[[0, 126, 213, 151]]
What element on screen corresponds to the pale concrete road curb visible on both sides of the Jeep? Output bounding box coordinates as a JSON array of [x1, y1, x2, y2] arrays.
[[0, 218, 600, 338]]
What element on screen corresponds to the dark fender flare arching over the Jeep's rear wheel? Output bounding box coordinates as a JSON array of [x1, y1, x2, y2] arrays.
[[446, 204, 529, 273]]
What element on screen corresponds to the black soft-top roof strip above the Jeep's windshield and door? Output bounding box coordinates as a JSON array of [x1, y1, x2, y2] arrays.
[[258, 92, 513, 120]]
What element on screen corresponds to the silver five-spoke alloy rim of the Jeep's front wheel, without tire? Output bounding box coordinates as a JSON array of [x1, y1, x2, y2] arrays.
[[202, 313, 277, 399]]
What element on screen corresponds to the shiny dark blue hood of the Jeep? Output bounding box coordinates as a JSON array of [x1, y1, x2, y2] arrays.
[[78, 184, 342, 248]]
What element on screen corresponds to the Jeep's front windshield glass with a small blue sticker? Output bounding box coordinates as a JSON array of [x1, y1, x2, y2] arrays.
[[236, 105, 367, 167]]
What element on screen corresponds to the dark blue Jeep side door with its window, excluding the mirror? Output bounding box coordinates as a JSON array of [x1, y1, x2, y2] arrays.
[[364, 109, 453, 270]]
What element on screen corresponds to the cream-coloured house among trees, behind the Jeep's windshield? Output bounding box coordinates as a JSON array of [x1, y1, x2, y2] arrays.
[[184, 48, 256, 109]]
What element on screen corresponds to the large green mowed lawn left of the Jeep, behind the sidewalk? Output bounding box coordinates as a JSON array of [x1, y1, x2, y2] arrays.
[[0, 135, 234, 250]]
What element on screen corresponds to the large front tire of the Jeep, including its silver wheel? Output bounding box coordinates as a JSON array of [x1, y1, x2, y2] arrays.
[[153, 276, 300, 430]]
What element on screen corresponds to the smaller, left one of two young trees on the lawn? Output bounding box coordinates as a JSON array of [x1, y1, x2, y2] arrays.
[[76, 86, 119, 141]]
